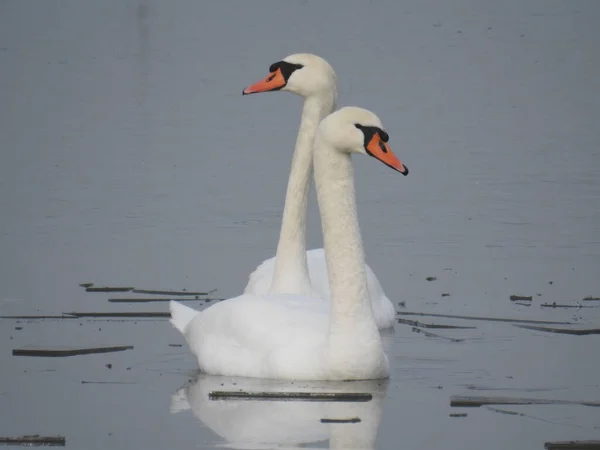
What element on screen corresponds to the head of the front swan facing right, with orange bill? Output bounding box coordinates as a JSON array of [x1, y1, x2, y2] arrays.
[[317, 106, 408, 175]]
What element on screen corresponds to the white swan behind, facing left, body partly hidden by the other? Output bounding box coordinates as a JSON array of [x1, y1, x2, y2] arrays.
[[243, 53, 396, 329]]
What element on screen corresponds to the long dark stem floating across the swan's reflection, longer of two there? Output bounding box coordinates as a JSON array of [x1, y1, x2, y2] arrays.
[[208, 391, 373, 402]]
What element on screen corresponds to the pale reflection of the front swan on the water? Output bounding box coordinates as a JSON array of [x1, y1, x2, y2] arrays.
[[171, 373, 388, 449]]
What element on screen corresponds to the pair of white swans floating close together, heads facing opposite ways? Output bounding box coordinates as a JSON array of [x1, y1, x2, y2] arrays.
[[170, 54, 408, 380]]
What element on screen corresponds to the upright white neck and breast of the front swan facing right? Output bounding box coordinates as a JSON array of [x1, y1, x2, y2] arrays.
[[314, 135, 385, 379]]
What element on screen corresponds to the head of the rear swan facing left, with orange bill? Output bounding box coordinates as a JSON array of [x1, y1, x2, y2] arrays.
[[243, 53, 336, 98]]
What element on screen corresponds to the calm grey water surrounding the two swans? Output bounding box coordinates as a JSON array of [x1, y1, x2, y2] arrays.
[[0, 0, 600, 450]]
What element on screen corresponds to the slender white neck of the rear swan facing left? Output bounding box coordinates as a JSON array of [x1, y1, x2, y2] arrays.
[[269, 90, 336, 295]]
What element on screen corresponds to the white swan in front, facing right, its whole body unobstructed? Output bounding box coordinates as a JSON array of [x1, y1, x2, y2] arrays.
[[169, 107, 408, 381]]
